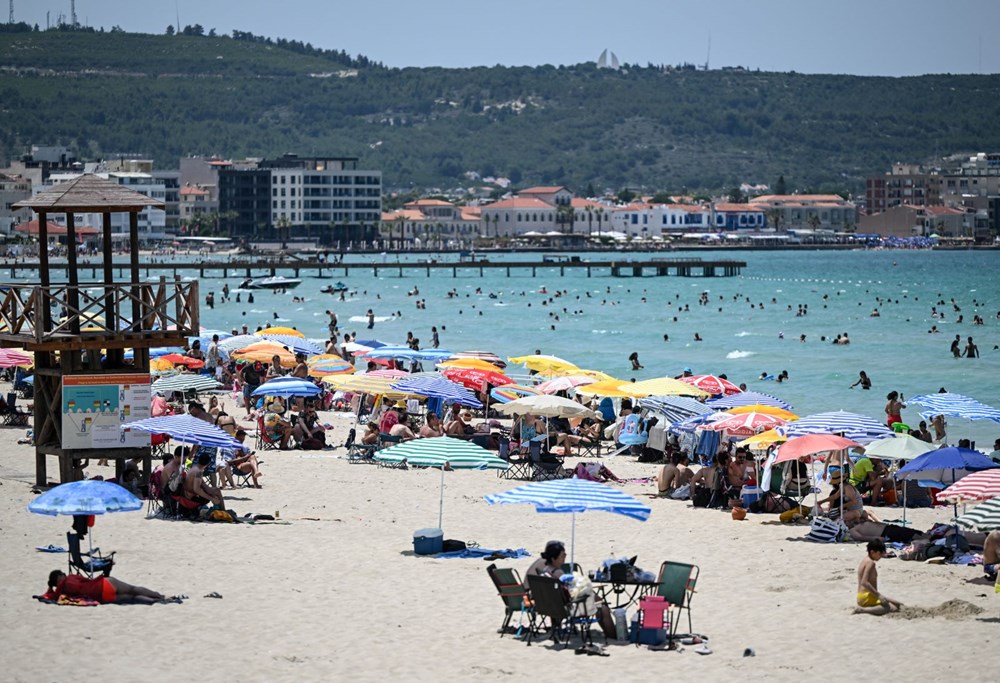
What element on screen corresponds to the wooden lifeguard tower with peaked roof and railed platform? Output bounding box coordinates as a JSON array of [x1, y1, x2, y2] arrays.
[[0, 174, 199, 486]]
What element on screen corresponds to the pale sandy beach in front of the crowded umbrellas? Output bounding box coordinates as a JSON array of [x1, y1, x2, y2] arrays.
[[0, 400, 1000, 681]]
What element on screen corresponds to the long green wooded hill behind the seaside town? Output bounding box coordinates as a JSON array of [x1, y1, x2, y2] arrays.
[[0, 30, 1000, 191]]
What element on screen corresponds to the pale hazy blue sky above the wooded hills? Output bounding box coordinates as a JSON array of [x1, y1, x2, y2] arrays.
[[14, 0, 1000, 76]]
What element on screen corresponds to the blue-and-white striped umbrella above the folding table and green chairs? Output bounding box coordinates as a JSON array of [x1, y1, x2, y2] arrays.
[[485, 479, 652, 563]]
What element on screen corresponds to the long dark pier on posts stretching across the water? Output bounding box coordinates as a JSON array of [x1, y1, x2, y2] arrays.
[[8, 258, 746, 279]]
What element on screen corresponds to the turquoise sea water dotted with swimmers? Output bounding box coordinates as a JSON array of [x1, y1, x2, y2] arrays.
[[31, 250, 1000, 448]]
